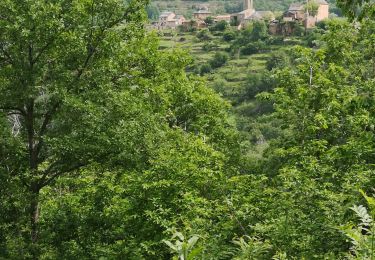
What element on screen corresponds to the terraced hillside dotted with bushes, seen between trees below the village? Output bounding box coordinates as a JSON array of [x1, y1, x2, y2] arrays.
[[160, 22, 314, 158]]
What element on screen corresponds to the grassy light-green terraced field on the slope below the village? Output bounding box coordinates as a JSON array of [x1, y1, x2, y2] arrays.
[[160, 31, 288, 155]]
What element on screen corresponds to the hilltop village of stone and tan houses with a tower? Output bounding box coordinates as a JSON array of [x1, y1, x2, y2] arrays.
[[152, 0, 329, 34]]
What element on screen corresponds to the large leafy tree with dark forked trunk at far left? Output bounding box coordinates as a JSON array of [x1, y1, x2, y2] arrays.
[[0, 0, 152, 254]]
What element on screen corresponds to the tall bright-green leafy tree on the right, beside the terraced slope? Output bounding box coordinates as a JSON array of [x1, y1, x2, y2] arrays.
[[258, 18, 375, 258]]
